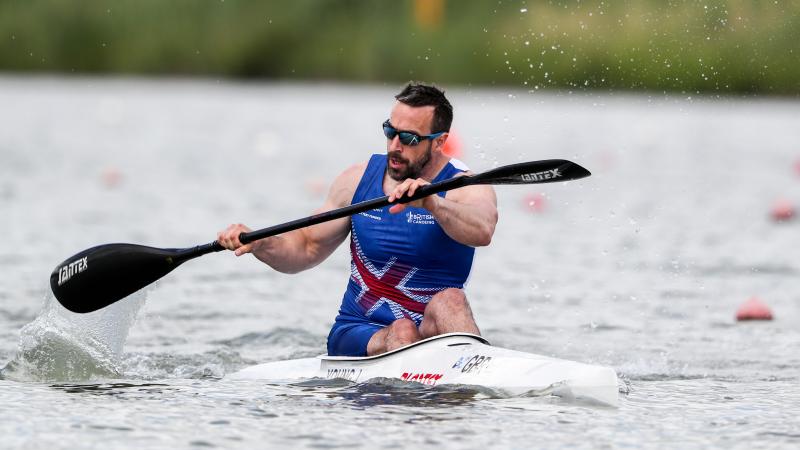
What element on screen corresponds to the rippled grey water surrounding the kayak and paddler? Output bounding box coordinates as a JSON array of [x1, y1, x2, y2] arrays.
[[0, 77, 800, 449]]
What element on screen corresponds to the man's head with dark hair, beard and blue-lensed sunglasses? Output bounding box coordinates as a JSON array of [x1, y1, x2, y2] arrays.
[[383, 83, 453, 181]]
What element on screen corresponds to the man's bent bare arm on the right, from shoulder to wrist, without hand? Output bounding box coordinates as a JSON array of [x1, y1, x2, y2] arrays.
[[429, 195, 497, 247]]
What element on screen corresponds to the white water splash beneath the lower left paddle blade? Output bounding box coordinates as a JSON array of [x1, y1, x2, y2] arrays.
[[0, 292, 146, 382]]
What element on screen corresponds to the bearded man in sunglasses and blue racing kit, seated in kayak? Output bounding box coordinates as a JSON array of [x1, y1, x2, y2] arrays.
[[217, 83, 497, 356]]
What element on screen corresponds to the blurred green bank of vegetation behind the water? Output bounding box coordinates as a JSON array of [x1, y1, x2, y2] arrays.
[[0, 0, 800, 96]]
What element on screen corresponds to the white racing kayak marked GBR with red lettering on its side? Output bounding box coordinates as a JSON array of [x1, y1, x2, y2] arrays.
[[228, 333, 619, 406]]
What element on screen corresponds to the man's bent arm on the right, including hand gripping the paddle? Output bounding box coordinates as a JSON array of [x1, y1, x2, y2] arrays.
[[389, 178, 497, 247]]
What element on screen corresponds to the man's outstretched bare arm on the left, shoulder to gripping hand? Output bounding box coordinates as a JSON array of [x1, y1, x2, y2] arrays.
[[212, 163, 366, 273]]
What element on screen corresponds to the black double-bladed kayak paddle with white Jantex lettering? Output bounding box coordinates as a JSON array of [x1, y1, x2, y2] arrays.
[[50, 159, 591, 313]]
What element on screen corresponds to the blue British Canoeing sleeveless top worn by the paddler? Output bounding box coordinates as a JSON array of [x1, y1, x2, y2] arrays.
[[336, 154, 475, 325]]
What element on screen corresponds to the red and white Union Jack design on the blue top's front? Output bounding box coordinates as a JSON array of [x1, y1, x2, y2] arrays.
[[350, 233, 446, 325]]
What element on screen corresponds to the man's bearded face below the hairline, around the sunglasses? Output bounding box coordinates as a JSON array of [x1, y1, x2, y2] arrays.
[[386, 102, 446, 181]]
